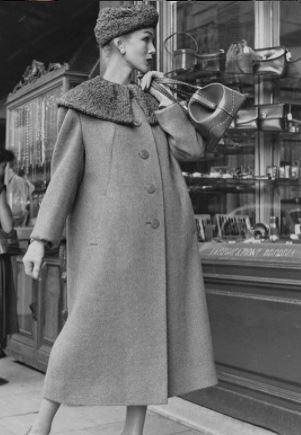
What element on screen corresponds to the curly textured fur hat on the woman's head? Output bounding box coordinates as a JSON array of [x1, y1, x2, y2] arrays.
[[94, 4, 159, 46]]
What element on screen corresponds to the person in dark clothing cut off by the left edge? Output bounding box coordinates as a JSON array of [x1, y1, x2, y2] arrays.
[[0, 150, 18, 358]]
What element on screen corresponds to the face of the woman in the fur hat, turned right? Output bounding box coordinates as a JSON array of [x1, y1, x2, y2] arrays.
[[124, 28, 156, 73]]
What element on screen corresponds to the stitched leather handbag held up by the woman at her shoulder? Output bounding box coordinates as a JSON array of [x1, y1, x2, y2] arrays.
[[152, 78, 246, 152]]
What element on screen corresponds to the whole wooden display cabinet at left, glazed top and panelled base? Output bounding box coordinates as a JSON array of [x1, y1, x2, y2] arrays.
[[6, 61, 87, 371]]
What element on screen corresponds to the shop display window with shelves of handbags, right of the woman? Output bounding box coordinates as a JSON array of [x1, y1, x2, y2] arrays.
[[162, 1, 301, 243]]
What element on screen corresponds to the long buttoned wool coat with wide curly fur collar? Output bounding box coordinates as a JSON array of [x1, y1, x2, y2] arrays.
[[32, 77, 216, 405]]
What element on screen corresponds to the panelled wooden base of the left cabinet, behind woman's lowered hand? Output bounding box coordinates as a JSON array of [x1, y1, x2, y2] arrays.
[[7, 247, 67, 371]]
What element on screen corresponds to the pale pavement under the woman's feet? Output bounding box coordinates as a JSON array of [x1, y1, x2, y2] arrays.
[[0, 357, 272, 435]]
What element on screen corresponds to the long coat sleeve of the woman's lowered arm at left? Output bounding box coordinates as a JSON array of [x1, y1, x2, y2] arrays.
[[31, 108, 84, 246]]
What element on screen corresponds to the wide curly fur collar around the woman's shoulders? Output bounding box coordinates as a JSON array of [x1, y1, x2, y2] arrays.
[[58, 76, 159, 126]]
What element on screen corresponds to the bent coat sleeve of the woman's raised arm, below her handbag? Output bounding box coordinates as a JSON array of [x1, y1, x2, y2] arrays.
[[156, 104, 205, 162]]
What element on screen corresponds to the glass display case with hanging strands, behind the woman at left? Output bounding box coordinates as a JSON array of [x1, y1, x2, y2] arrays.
[[6, 61, 87, 227]]
